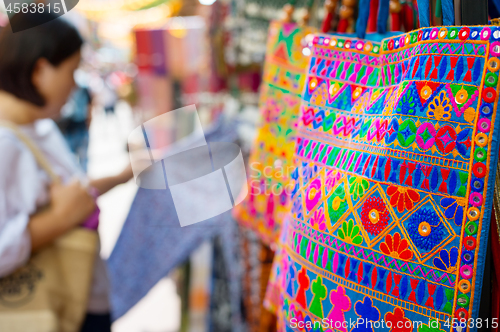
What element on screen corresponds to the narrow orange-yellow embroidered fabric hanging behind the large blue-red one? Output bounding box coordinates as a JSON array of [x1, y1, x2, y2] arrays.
[[234, 22, 313, 245]]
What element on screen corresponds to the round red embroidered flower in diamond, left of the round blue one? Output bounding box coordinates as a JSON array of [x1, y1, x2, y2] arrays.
[[361, 197, 389, 236]]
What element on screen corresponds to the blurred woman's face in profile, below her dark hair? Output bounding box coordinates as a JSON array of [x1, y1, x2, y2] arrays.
[[33, 51, 81, 118]]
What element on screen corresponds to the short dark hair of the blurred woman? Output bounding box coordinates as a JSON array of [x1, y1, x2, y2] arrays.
[[0, 13, 83, 106]]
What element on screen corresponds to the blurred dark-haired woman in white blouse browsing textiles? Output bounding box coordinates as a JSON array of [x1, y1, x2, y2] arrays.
[[0, 13, 132, 332]]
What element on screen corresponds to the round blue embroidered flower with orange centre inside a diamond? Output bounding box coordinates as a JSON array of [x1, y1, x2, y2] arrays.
[[406, 208, 446, 250]]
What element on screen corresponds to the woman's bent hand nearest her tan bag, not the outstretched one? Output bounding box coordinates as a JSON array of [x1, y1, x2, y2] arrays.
[[50, 179, 96, 226]]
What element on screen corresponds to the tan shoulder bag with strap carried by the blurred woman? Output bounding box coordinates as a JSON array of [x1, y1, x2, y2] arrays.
[[0, 121, 98, 332]]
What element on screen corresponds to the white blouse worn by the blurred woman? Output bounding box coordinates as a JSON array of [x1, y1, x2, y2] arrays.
[[0, 119, 109, 313]]
